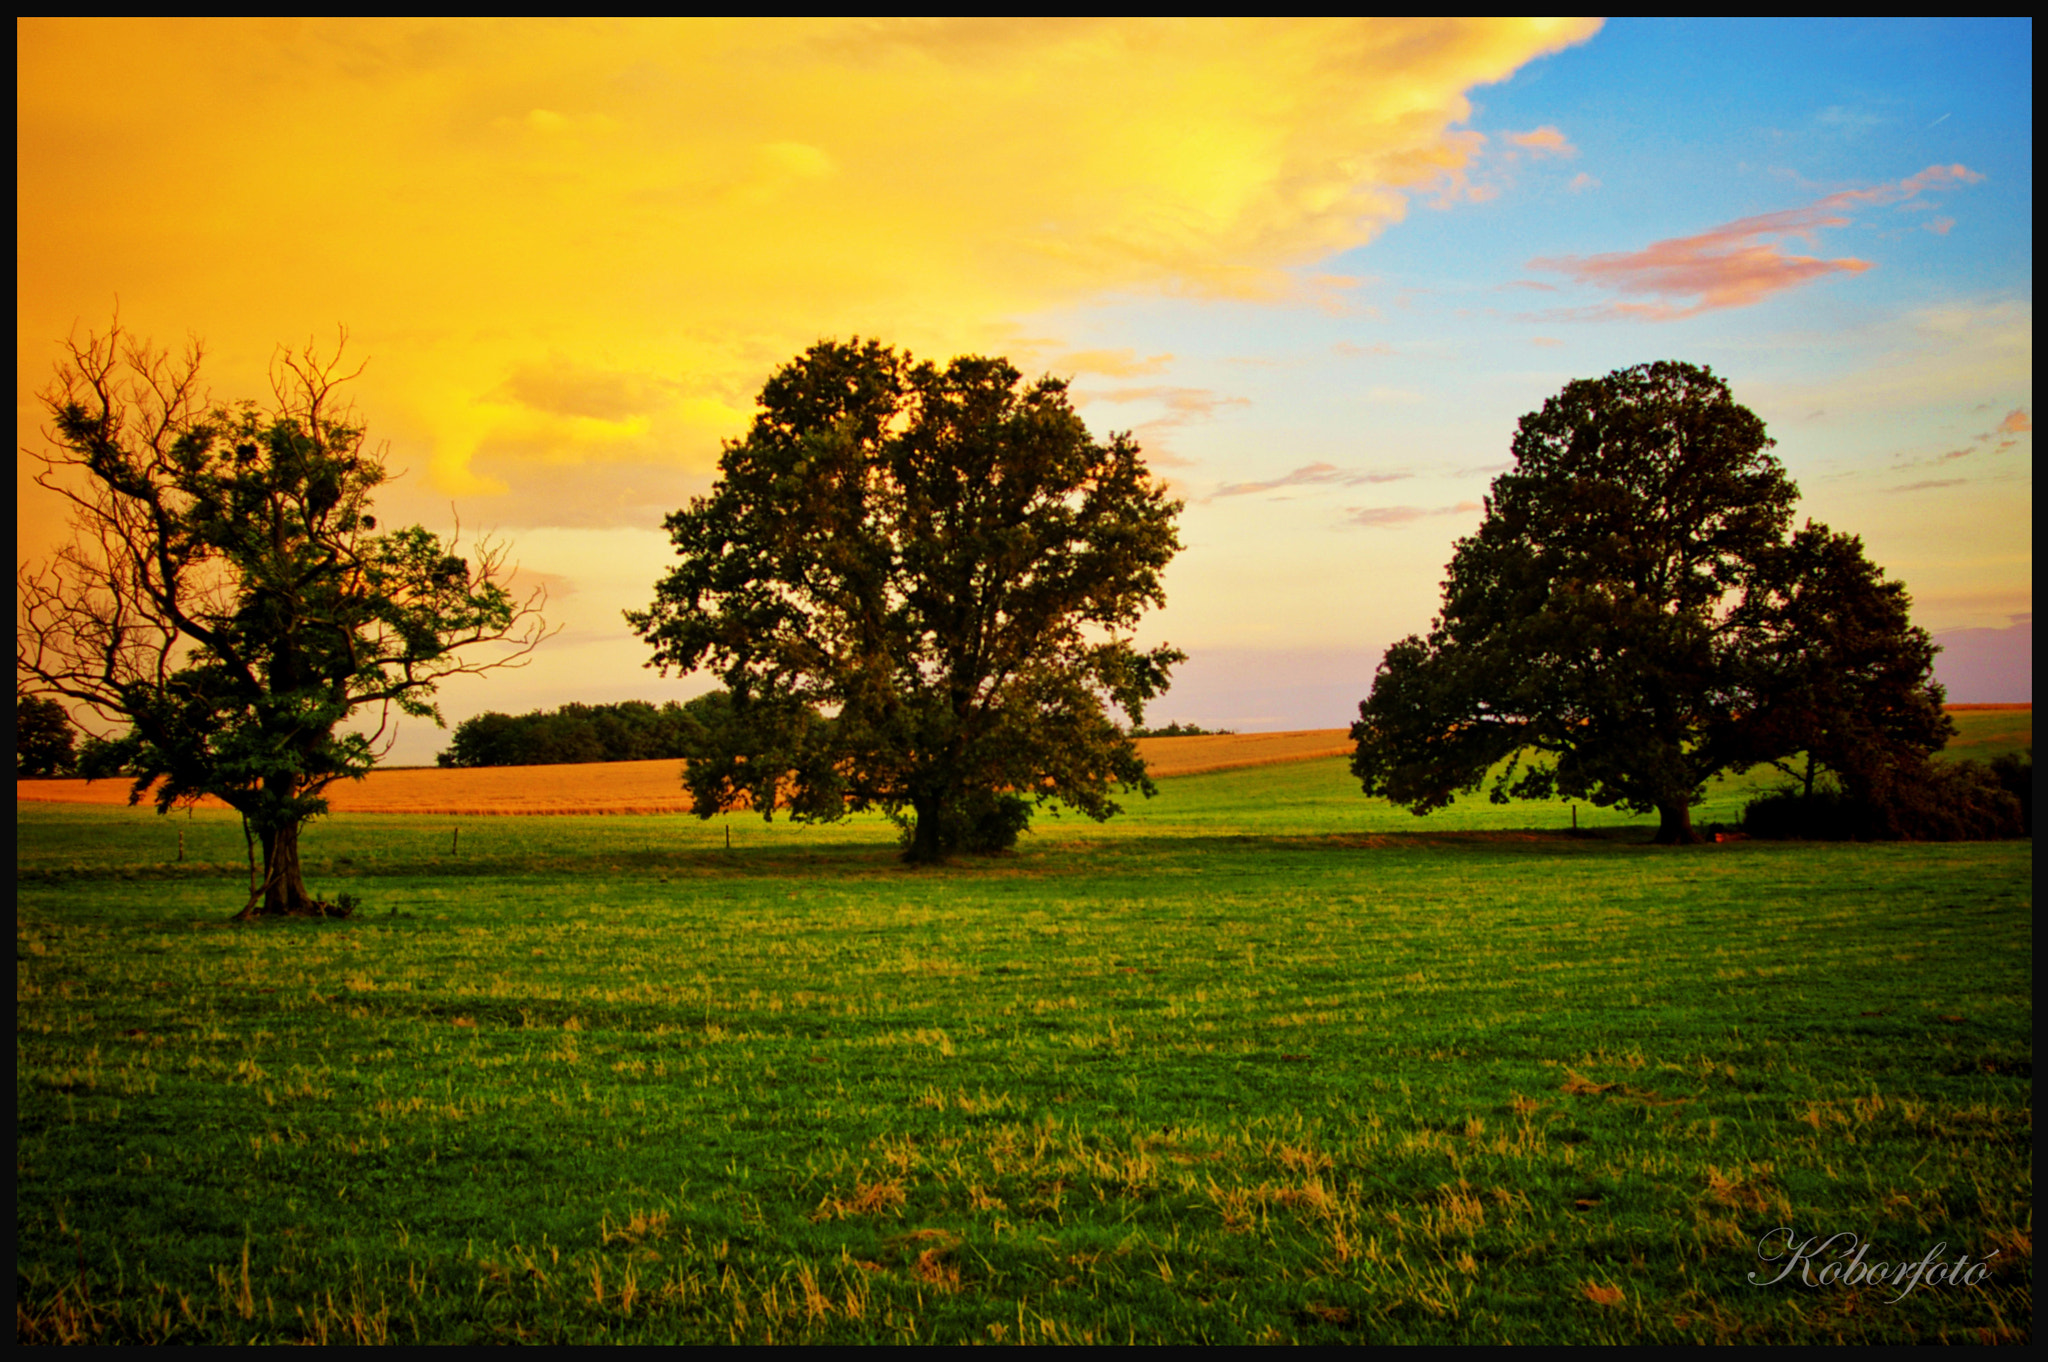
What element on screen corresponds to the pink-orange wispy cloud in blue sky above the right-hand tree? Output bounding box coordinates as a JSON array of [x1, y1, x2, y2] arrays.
[[1530, 166, 1985, 322]]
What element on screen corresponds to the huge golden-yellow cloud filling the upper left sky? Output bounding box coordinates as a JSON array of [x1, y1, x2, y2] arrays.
[[16, 18, 1597, 532]]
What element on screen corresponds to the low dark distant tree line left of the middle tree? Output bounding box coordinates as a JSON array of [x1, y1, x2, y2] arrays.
[[436, 696, 717, 766]]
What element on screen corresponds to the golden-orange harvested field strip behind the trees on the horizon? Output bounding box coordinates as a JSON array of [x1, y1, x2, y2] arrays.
[[14, 729, 1352, 813]]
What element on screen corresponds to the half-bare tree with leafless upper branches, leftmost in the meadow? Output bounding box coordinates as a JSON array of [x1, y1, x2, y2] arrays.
[[14, 326, 543, 916]]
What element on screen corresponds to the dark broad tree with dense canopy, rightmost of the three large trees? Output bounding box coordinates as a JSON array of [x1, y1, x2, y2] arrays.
[[1352, 363, 1952, 844]]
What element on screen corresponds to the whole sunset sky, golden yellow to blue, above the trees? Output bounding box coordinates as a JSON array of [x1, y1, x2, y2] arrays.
[[16, 18, 2032, 762]]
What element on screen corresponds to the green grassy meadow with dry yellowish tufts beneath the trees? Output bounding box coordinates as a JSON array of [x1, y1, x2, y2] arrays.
[[14, 711, 2034, 1344]]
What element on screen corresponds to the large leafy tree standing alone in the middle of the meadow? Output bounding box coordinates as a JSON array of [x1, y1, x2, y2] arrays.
[[627, 340, 1182, 860]]
